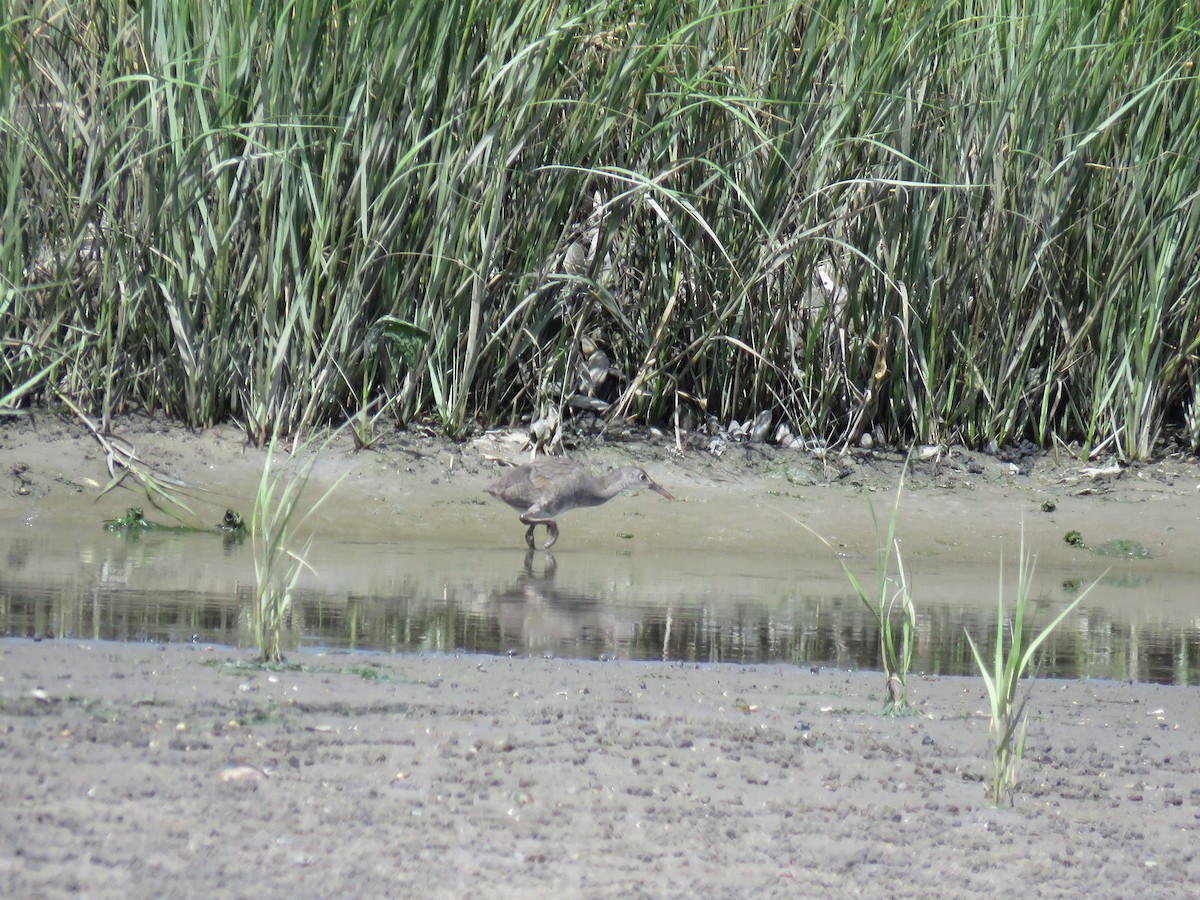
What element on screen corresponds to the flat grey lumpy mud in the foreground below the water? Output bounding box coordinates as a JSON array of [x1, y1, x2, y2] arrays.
[[0, 641, 1200, 898]]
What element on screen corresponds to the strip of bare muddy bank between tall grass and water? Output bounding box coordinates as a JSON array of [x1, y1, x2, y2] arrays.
[[7, 414, 1200, 572]]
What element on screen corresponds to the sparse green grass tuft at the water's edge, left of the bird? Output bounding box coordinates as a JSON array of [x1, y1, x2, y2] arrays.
[[251, 432, 344, 664]]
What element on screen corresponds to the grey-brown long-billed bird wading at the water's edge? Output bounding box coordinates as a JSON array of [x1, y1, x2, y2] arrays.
[[484, 456, 674, 550]]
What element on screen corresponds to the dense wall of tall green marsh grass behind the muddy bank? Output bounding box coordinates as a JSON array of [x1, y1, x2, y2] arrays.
[[0, 0, 1200, 458]]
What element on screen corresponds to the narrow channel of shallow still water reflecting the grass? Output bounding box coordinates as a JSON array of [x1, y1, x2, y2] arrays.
[[0, 528, 1200, 684]]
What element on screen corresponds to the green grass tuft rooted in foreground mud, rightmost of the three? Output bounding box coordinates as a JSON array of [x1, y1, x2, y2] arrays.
[[964, 529, 1104, 805]]
